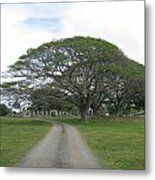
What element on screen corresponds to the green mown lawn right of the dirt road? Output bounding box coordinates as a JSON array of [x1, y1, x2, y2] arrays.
[[77, 118, 145, 170]]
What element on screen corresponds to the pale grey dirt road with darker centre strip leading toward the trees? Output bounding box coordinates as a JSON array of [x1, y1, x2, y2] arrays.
[[19, 124, 99, 168]]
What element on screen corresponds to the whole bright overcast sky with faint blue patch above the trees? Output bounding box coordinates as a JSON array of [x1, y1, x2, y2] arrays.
[[1, 1, 144, 71]]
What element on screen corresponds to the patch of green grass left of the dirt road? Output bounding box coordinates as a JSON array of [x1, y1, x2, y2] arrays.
[[0, 118, 51, 166]]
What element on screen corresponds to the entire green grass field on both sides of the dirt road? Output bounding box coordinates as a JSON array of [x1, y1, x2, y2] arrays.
[[0, 117, 145, 170]]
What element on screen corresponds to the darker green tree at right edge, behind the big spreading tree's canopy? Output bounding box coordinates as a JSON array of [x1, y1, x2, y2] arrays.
[[101, 60, 145, 116]]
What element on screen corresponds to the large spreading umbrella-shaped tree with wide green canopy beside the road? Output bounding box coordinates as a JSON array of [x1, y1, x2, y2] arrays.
[[3, 37, 143, 120]]
